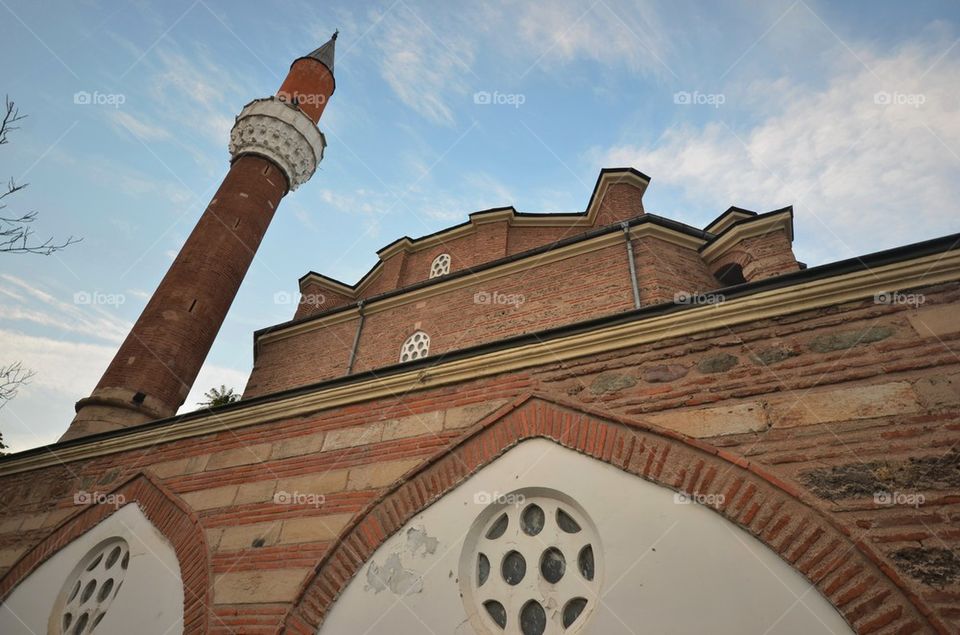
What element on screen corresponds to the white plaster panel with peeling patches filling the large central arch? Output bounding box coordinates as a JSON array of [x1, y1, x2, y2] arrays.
[[319, 439, 852, 635]]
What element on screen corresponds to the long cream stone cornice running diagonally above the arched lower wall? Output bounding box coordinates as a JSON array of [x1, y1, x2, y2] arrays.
[[0, 243, 960, 475]]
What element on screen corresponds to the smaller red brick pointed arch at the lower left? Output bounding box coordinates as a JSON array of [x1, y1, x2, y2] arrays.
[[0, 473, 211, 635]]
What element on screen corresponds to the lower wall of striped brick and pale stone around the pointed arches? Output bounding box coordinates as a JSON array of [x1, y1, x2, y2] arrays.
[[0, 280, 960, 633]]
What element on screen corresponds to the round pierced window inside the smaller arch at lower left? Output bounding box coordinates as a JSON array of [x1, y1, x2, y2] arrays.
[[48, 538, 130, 635]]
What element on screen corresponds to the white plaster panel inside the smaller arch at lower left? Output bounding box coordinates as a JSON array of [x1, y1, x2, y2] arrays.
[[0, 503, 183, 635]]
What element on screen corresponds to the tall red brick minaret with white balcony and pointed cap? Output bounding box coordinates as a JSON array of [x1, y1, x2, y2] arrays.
[[60, 33, 337, 441]]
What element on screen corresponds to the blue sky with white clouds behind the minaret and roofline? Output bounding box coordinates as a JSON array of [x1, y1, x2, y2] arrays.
[[0, 0, 960, 458]]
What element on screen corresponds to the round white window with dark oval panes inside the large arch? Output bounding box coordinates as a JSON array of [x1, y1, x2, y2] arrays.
[[460, 488, 602, 635]]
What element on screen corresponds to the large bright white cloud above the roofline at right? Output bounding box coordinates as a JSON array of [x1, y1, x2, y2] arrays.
[[591, 40, 960, 264]]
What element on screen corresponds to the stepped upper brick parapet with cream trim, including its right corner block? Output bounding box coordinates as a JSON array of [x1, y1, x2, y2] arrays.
[[294, 168, 800, 319]]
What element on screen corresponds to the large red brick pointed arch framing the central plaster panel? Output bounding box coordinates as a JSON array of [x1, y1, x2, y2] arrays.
[[281, 395, 949, 635]]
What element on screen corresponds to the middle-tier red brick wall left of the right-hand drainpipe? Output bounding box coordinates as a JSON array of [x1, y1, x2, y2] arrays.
[[244, 244, 632, 397]]
